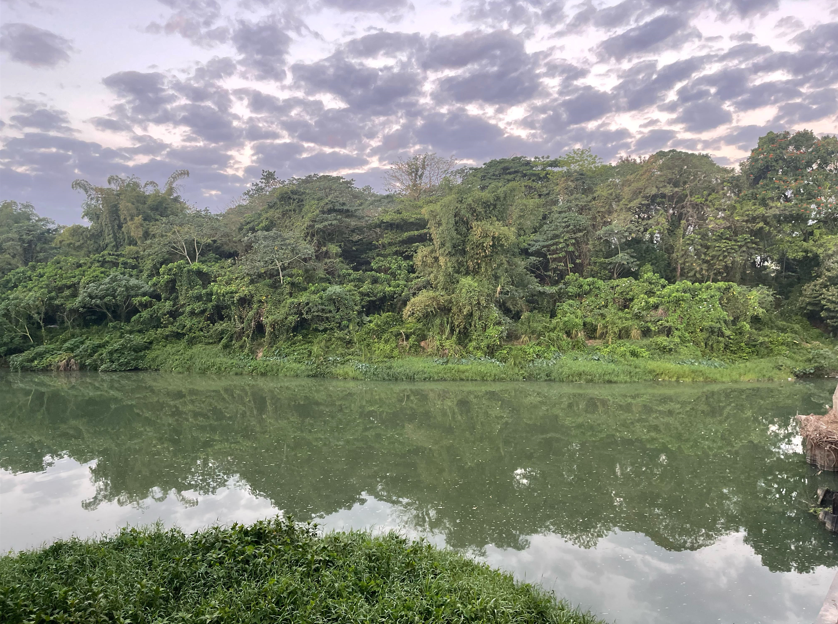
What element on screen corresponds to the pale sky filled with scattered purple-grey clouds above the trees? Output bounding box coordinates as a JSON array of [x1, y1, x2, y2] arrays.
[[0, 0, 838, 223]]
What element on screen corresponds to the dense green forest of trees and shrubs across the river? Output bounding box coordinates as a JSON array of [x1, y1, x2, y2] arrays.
[[0, 131, 838, 377]]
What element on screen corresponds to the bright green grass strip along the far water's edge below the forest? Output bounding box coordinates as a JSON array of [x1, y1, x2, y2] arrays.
[[146, 343, 801, 383]]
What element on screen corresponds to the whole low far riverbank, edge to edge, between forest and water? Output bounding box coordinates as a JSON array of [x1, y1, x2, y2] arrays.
[[6, 337, 838, 383]]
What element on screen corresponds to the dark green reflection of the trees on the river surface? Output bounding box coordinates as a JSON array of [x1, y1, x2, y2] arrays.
[[0, 373, 836, 572]]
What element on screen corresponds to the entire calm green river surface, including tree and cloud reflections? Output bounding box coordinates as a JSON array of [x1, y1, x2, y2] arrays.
[[0, 373, 838, 624]]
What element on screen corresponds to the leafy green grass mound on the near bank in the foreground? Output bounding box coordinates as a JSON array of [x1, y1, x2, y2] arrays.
[[0, 519, 599, 624]]
